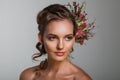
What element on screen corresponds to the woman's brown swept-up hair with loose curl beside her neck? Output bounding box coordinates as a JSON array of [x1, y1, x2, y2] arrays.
[[32, 4, 77, 60]]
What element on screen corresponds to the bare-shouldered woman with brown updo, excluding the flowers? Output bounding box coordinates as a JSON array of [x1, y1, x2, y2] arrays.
[[20, 4, 91, 80]]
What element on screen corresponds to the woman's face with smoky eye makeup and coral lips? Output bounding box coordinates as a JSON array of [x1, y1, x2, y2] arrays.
[[43, 19, 75, 61]]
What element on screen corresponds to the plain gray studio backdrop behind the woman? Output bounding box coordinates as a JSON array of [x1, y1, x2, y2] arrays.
[[0, 0, 120, 80]]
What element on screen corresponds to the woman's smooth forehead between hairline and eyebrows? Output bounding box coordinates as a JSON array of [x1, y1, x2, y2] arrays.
[[45, 19, 74, 33]]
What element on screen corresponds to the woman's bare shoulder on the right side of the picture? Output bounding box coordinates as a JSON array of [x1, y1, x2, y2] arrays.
[[74, 66, 92, 80]]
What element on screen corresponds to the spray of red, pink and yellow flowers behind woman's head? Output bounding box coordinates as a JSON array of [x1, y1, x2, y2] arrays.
[[66, 2, 95, 45]]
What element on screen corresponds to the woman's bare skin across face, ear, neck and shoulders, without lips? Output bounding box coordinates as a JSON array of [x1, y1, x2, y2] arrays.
[[20, 19, 92, 80]]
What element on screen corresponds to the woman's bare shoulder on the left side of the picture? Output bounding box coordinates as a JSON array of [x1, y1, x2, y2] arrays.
[[19, 66, 39, 80]]
